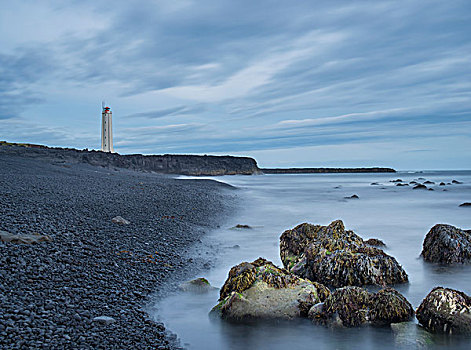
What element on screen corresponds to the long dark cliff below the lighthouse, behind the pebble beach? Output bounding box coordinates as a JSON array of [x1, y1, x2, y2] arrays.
[[0, 143, 259, 176]]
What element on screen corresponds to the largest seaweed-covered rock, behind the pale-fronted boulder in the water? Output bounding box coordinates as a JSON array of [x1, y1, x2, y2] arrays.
[[280, 220, 408, 287]]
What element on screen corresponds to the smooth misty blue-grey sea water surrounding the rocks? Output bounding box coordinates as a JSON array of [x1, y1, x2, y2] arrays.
[[152, 171, 471, 350]]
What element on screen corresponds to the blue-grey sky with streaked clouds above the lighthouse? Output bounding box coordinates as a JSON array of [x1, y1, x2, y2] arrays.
[[0, 0, 471, 170]]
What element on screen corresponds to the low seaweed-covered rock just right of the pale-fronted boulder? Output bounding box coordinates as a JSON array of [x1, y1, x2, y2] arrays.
[[308, 287, 414, 327]]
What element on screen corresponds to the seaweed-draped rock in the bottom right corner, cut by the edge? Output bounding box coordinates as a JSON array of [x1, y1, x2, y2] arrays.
[[416, 287, 471, 334]]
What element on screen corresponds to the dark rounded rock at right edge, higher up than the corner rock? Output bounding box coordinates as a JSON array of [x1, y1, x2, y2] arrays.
[[421, 224, 471, 264]]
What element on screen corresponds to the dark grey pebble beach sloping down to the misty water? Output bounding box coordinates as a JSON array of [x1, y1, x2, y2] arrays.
[[0, 154, 234, 349]]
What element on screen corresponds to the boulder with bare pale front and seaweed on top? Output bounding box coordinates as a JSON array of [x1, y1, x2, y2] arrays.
[[211, 258, 330, 320]]
